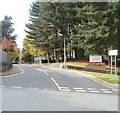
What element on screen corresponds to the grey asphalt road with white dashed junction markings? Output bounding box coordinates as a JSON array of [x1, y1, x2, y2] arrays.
[[1, 65, 118, 111]]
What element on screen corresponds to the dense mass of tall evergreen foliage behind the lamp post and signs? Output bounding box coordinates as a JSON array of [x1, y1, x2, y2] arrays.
[[25, 2, 120, 59]]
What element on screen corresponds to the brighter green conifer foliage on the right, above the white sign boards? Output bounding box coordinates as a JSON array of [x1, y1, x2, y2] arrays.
[[75, 2, 118, 55]]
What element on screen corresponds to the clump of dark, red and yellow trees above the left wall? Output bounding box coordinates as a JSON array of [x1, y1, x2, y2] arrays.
[[0, 16, 19, 61]]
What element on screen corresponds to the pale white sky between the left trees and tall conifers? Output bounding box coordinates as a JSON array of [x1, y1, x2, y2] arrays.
[[0, 0, 35, 48]]
